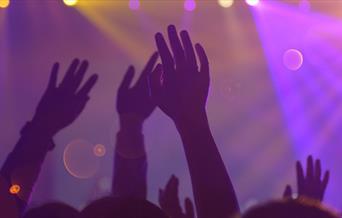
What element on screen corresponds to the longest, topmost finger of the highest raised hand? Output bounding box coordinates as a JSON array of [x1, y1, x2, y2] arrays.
[[168, 25, 185, 68]]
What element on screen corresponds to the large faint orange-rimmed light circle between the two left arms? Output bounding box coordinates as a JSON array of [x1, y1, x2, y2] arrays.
[[63, 139, 100, 179]]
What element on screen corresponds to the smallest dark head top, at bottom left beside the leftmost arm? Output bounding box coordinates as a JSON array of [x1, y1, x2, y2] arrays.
[[23, 202, 79, 218]]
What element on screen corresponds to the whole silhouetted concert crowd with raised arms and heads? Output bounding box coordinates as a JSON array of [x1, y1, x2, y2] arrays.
[[0, 25, 340, 218]]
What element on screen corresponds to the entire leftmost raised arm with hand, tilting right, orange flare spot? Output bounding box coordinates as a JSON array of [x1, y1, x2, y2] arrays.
[[0, 59, 97, 212]]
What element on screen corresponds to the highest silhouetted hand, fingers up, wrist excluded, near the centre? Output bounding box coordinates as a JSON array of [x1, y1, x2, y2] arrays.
[[151, 25, 210, 122]]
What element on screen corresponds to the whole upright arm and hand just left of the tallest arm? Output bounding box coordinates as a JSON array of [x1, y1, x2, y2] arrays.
[[112, 53, 158, 199]]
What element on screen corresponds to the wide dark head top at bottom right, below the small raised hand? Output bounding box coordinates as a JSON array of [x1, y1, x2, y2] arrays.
[[242, 198, 339, 218]]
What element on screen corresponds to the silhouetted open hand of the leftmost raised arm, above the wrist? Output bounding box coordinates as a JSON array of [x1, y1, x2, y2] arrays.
[[33, 59, 98, 136]]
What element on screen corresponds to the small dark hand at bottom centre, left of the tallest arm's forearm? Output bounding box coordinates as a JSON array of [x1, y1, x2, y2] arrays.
[[159, 176, 195, 218]]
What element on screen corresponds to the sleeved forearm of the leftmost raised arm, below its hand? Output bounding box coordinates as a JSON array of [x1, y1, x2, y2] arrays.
[[0, 122, 53, 212]]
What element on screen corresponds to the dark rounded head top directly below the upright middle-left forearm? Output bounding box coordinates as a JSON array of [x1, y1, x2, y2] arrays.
[[80, 197, 167, 218]]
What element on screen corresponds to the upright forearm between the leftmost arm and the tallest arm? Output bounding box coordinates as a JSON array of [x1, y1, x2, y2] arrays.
[[112, 116, 147, 199]]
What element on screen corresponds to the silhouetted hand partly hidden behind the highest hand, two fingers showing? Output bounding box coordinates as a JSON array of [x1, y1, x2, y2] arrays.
[[117, 52, 158, 121]]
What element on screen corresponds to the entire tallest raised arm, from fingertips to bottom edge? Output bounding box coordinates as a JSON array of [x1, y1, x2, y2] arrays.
[[151, 25, 239, 218]]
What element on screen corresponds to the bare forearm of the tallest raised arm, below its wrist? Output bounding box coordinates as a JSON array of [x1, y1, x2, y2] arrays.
[[176, 115, 239, 218]]
